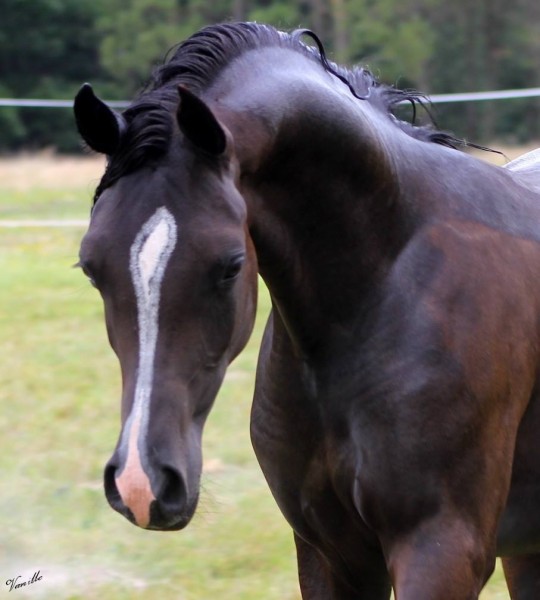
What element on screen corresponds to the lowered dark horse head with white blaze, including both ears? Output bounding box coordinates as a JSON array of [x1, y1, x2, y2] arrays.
[[75, 85, 257, 530]]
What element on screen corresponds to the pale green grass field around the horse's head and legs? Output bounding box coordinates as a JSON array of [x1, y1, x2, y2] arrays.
[[0, 151, 532, 600]]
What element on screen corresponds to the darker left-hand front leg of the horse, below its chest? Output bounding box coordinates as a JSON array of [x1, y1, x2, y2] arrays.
[[294, 533, 391, 600]]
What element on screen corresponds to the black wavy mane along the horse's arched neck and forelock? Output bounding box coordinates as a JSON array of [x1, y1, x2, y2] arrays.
[[94, 23, 465, 202]]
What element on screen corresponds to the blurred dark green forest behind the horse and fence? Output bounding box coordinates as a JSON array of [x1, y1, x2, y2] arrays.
[[0, 0, 540, 153]]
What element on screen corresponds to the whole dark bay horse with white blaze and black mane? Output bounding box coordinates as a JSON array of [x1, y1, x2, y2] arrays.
[[75, 23, 540, 600]]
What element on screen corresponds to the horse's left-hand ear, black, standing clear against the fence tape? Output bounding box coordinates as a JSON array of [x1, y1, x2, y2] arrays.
[[73, 83, 126, 155]]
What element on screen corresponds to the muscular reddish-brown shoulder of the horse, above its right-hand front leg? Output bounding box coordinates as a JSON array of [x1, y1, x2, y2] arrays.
[[300, 222, 540, 539]]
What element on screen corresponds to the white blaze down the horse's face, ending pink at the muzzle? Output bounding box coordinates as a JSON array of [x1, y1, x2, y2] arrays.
[[116, 207, 177, 526]]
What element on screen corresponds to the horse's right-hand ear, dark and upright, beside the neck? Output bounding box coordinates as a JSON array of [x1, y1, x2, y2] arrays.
[[176, 85, 227, 156]]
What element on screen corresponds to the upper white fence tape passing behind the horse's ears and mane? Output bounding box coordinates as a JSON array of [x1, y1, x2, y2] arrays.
[[0, 87, 540, 108]]
